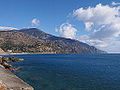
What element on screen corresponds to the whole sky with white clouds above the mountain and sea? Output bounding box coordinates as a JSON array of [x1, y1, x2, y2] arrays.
[[0, 0, 120, 53]]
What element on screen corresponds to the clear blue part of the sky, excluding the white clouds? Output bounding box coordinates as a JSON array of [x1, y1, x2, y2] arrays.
[[0, 0, 119, 52]]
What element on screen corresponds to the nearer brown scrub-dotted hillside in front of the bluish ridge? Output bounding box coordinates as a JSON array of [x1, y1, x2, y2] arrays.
[[0, 31, 60, 53]]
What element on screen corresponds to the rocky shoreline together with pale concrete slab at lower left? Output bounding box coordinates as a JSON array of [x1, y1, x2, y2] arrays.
[[0, 57, 34, 90]]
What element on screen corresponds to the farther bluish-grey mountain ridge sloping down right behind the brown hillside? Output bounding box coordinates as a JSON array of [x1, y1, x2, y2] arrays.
[[18, 28, 105, 53]]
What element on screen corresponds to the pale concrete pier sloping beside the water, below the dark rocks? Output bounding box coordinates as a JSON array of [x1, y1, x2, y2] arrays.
[[0, 66, 34, 90]]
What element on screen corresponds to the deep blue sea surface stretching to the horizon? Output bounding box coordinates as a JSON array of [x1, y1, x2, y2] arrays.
[[5, 54, 120, 90]]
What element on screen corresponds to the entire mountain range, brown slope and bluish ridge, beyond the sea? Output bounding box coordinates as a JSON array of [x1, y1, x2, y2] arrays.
[[0, 28, 105, 53]]
